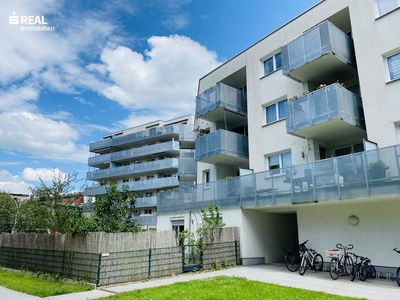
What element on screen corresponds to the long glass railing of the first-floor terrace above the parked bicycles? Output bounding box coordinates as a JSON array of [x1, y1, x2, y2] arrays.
[[157, 145, 400, 214]]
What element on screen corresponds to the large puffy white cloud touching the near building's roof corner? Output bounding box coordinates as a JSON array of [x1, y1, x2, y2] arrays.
[[101, 35, 219, 114]]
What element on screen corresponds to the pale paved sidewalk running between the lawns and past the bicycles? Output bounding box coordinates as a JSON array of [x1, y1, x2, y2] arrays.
[[0, 265, 400, 300]]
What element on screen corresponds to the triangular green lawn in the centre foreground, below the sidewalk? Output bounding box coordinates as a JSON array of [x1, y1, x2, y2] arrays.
[[105, 276, 366, 300]]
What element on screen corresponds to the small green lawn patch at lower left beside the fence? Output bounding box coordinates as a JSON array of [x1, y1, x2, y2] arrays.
[[0, 270, 92, 298]]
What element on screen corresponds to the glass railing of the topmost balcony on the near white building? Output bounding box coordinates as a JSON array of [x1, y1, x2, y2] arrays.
[[281, 21, 356, 82]]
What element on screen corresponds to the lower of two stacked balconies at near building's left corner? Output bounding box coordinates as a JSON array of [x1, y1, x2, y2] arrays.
[[195, 129, 249, 166]]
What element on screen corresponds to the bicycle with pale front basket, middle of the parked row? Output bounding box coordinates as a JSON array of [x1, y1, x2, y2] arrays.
[[326, 244, 353, 280]]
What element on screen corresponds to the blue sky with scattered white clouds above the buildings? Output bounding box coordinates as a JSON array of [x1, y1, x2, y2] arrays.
[[0, 0, 319, 193]]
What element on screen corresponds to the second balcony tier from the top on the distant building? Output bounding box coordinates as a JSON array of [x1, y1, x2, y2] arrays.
[[88, 141, 179, 168]]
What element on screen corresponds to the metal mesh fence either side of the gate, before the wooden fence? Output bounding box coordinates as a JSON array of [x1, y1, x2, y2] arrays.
[[0, 241, 240, 287]]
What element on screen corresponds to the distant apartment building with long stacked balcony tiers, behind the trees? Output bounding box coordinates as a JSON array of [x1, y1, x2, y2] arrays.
[[86, 115, 196, 228]]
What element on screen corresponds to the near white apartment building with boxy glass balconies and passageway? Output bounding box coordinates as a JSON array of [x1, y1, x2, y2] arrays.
[[157, 0, 400, 268]]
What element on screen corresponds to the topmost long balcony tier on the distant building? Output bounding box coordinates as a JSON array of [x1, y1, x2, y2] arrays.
[[89, 124, 196, 153]]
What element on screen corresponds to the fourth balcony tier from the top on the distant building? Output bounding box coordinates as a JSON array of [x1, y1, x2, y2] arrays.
[[85, 177, 179, 196]]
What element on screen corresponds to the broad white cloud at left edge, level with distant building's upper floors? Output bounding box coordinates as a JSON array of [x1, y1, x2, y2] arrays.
[[0, 112, 88, 163]]
